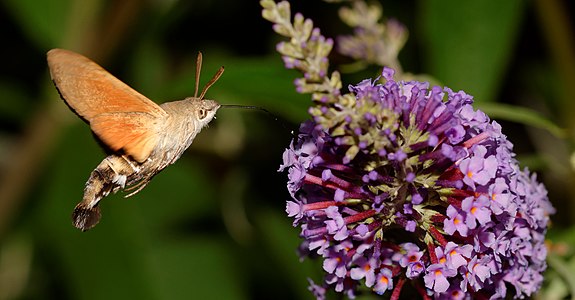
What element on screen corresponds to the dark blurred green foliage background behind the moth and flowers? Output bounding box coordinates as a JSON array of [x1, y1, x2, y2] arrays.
[[0, 0, 575, 300]]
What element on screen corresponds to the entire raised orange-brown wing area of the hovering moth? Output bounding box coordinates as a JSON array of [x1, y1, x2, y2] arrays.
[[47, 49, 168, 162]]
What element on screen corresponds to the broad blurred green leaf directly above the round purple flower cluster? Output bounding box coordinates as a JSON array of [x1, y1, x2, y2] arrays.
[[419, 0, 526, 102]]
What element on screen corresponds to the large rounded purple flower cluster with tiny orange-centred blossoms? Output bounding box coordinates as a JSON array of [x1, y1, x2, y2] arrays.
[[280, 68, 554, 299]]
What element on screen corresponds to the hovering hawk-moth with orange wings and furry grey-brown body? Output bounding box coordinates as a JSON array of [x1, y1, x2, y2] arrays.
[[47, 49, 224, 231]]
